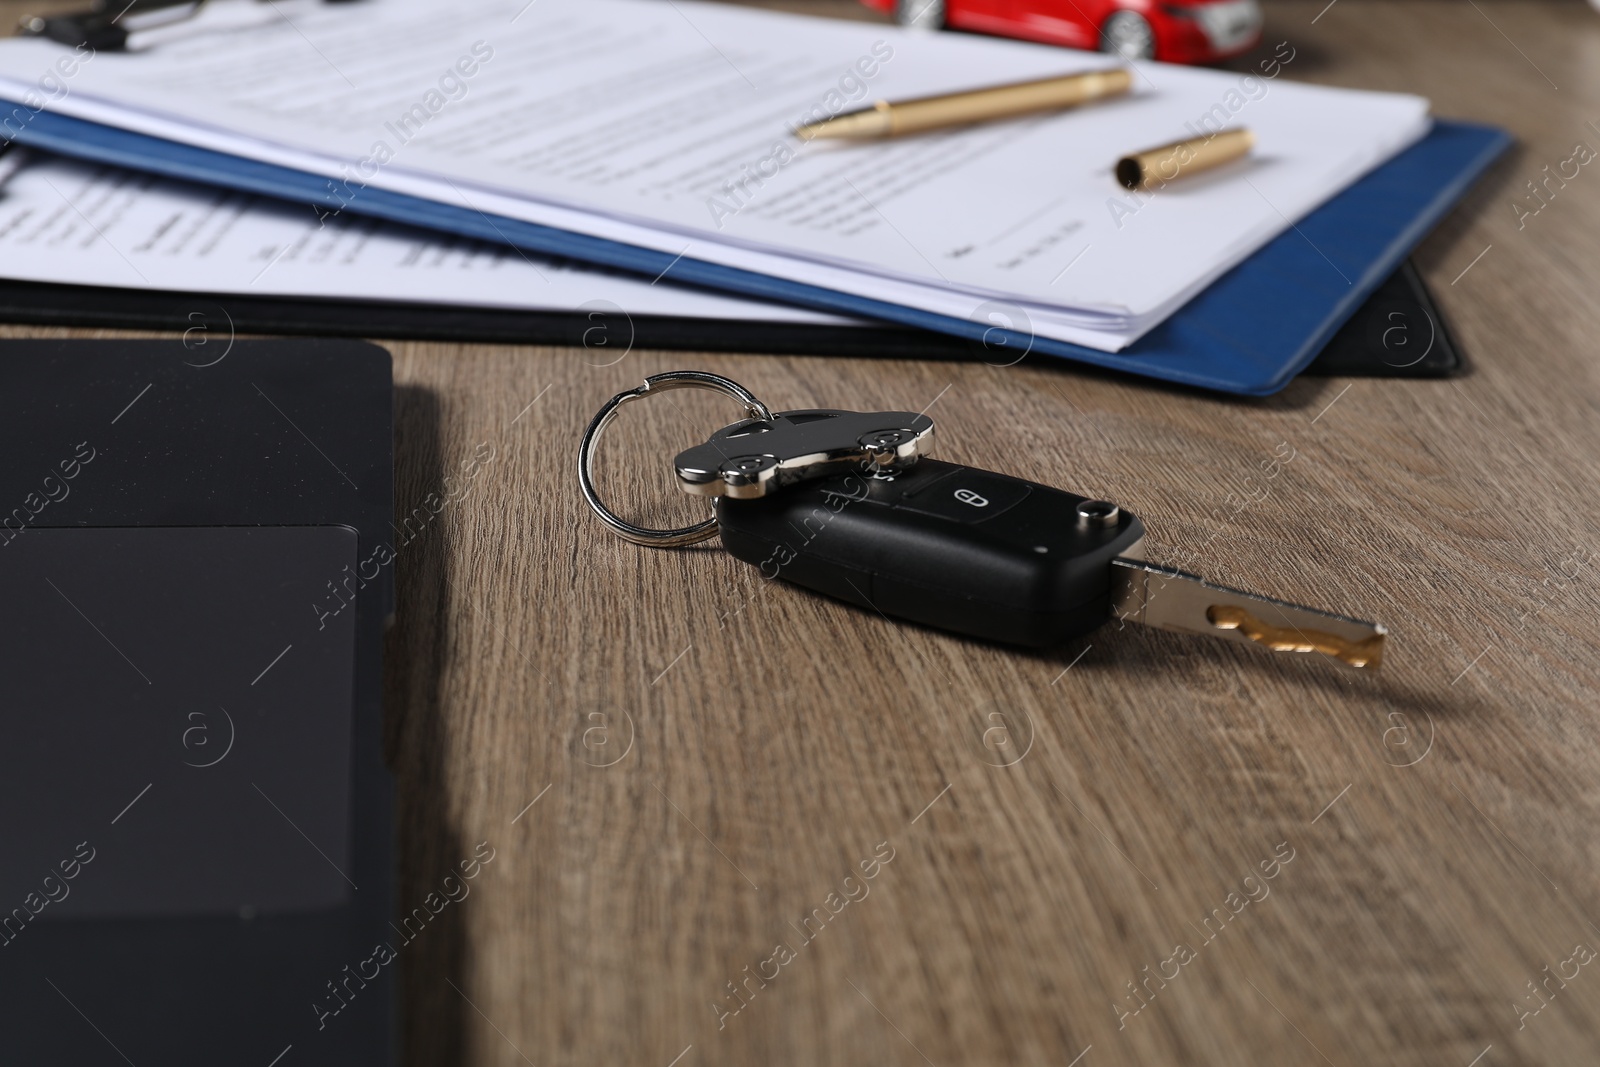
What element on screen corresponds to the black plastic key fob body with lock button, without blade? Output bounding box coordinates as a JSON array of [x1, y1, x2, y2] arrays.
[[715, 458, 1144, 648]]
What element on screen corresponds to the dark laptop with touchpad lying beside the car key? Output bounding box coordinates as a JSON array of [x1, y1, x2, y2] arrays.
[[0, 341, 403, 1067]]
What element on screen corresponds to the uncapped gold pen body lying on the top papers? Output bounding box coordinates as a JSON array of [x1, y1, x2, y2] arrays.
[[795, 67, 1133, 141]]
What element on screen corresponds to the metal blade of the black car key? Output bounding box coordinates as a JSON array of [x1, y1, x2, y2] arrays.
[[1112, 558, 1387, 670]]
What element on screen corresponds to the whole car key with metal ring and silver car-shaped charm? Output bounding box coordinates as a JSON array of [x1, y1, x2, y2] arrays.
[[578, 371, 1386, 669]]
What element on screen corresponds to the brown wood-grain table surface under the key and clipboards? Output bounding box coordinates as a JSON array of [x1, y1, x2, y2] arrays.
[[5, 0, 1600, 1067]]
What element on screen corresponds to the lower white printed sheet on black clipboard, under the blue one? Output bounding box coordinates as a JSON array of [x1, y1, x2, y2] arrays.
[[0, 149, 859, 325]]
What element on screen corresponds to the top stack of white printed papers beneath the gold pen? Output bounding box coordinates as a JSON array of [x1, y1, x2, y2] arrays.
[[0, 0, 1429, 350]]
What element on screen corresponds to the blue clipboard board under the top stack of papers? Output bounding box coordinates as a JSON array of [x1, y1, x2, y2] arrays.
[[3, 112, 1510, 397]]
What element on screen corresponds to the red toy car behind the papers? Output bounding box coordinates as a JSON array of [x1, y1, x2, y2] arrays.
[[862, 0, 1261, 62]]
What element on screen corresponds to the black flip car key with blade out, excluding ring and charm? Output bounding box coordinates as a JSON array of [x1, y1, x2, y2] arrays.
[[700, 459, 1384, 667]]
